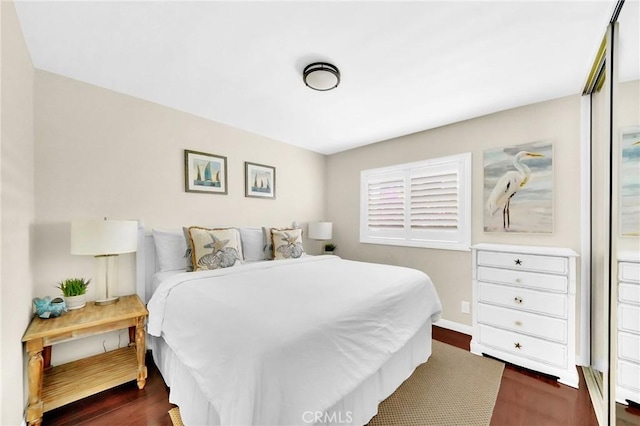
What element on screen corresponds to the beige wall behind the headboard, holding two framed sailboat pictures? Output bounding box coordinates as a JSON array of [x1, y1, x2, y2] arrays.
[[33, 71, 326, 363]]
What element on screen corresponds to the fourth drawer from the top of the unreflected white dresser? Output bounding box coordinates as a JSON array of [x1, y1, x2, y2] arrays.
[[477, 303, 567, 343]]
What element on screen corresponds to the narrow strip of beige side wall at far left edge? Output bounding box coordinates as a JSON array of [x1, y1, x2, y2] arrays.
[[0, 1, 34, 425]]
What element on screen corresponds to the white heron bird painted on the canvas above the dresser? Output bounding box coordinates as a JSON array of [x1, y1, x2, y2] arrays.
[[487, 151, 544, 229]]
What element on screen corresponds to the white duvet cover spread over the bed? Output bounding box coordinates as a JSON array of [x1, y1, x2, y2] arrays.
[[148, 256, 441, 425]]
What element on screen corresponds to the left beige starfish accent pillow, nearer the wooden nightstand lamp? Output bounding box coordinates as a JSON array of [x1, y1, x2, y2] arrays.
[[188, 226, 242, 271]]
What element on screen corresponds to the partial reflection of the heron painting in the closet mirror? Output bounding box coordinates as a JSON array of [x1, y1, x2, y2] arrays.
[[619, 126, 640, 237]]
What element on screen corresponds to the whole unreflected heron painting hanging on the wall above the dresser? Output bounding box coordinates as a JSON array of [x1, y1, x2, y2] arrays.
[[483, 141, 553, 234]]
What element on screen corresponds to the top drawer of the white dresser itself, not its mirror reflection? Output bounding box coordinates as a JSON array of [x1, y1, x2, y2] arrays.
[[477, 251, 569, 274]]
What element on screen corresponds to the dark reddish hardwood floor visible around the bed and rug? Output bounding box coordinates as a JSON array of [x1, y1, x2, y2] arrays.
[[43, 327, 598, 426]]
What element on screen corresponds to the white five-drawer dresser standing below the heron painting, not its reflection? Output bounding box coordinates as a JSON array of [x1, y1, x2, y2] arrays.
[[471, 244, 578, 388]]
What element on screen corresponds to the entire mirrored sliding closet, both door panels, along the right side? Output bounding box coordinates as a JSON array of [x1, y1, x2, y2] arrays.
[[583, 1, 640, 425]]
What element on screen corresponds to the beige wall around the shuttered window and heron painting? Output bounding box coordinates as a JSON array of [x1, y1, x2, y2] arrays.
[[327, 96, 580, 326]]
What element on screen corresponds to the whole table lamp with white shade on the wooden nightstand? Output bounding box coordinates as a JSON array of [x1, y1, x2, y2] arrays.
[[71, 218, 138, 305]]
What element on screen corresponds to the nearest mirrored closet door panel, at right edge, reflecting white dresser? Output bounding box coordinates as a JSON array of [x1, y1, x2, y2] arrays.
[[610, 1, 640, 425]]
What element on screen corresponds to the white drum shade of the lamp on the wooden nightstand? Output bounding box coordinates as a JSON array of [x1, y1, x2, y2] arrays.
[[71, 220, 138, 256]]
